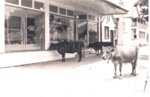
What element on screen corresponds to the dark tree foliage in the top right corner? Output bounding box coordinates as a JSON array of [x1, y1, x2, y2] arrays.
[[134, 0, 149, 21]]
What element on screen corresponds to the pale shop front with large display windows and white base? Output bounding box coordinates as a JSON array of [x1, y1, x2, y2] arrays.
[[0, 0, 127, 67]]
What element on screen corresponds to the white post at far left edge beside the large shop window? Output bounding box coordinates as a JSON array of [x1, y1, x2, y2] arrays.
[[0, 0, 5, 53]]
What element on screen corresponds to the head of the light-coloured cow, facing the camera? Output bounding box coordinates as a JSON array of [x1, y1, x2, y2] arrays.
[[102, 46, 114, 60]]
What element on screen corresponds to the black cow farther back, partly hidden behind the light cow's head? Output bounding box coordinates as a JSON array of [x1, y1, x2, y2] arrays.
[[88, 41, 113, 55]]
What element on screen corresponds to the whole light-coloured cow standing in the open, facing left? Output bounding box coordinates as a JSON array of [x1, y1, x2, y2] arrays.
[[102, 45, 138, 78]]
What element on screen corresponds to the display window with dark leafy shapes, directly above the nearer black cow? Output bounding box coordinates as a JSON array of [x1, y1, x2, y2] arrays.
[[50, 14, 74, 42]]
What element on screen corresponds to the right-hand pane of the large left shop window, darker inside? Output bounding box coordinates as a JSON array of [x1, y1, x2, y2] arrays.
[[27, 10, 45, 46]]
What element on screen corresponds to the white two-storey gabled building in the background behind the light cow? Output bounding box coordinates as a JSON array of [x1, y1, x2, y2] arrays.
[[114, 0, 148, 45]]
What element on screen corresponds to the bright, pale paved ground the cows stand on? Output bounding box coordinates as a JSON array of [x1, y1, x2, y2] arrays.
[[0, 46, 149, 97]]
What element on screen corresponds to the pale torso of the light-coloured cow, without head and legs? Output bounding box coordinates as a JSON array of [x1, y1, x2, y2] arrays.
[[113, 45, 138, 63]]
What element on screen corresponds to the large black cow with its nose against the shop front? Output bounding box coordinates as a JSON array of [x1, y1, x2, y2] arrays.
[[49, 41, 84, 62]]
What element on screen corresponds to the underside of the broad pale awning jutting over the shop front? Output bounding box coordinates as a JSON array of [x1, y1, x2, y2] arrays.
[[51, 0, 128, 15]]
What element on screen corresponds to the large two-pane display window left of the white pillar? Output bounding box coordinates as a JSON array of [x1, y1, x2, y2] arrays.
[[5, 6, 45, 51]]
